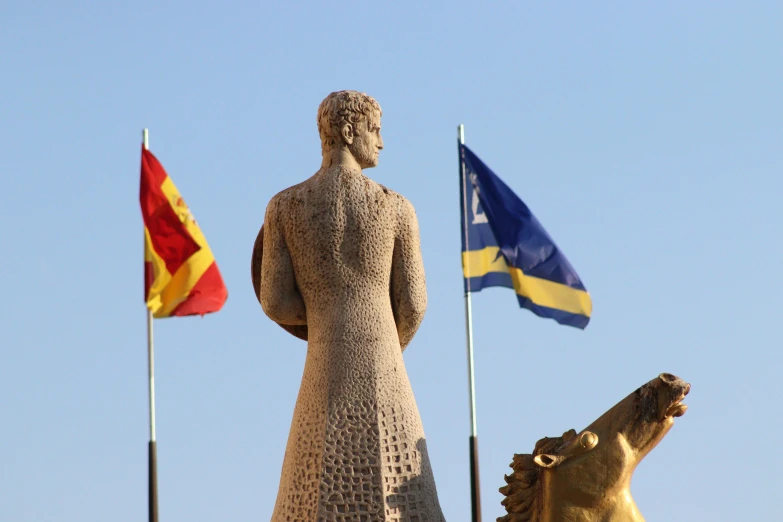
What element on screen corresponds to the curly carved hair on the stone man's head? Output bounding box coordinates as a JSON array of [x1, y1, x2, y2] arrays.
[[318, 91, 381, 150]]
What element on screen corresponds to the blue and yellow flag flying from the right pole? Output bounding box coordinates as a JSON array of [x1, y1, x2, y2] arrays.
[[460, 145, 593, 329]]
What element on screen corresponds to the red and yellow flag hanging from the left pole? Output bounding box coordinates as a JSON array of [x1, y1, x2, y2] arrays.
[[140, 147, 228, 318]]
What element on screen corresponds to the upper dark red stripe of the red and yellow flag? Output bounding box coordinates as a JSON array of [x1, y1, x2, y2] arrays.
[[139, 147, 200, 274]]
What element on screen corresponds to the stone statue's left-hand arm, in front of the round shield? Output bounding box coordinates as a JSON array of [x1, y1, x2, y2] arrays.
[[260, 196, 307, 325]]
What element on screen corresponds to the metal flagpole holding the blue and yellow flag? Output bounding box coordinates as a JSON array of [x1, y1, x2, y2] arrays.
[[457, 125, 481, 522]]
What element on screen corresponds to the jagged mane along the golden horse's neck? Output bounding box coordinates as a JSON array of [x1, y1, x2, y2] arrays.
[[497, 430, 576, 522]]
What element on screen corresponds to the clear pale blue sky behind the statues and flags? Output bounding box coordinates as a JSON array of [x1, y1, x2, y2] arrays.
[[0, 0, 783, 522]]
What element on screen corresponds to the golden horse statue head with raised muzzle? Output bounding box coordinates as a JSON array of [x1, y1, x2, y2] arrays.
[[497, 373, 691, 522]]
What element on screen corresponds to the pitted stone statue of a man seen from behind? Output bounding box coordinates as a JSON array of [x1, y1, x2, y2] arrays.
[[254, 91, 443, 522]]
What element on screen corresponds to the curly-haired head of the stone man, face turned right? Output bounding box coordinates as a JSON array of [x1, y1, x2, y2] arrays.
[[318, 91, 383, 169]]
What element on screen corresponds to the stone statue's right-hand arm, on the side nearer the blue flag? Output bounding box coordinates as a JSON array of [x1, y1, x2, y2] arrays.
[[390, 198, 427, 350]]
